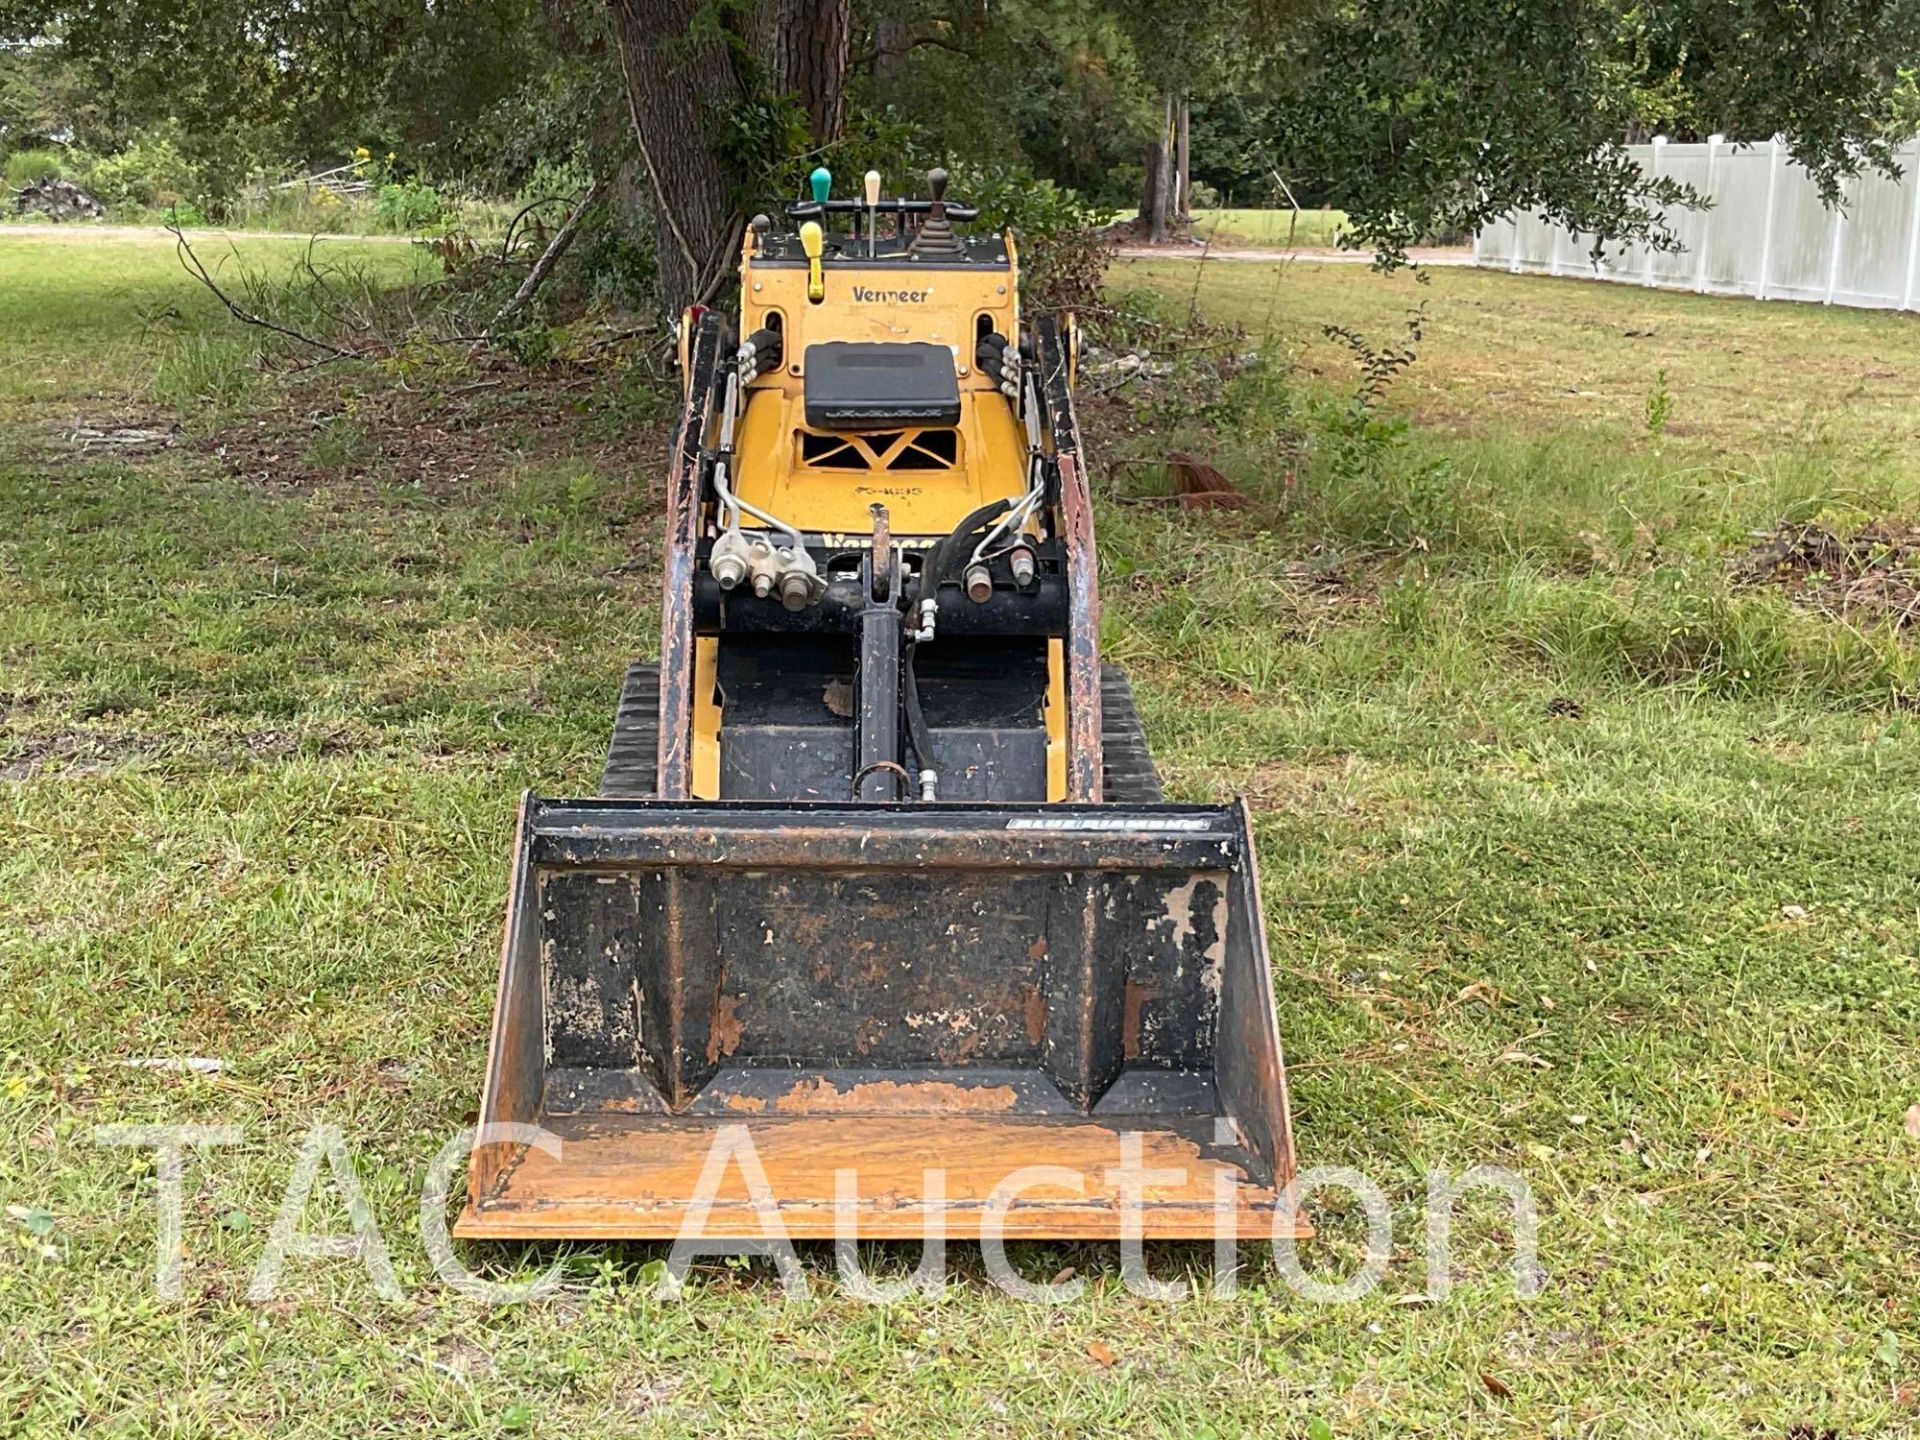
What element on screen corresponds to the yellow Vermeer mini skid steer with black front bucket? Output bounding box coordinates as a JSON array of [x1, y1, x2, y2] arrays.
[[457, 171, 1298, 1240]]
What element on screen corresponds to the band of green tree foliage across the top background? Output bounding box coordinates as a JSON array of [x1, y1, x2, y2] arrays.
[[0, 0, 1920, 301]]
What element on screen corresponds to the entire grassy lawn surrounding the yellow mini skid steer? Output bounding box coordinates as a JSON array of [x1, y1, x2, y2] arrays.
[[0, 232, 1920, 1438]]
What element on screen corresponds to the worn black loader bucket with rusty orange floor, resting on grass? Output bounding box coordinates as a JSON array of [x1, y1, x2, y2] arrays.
[[457, 797, 1298, 1238]]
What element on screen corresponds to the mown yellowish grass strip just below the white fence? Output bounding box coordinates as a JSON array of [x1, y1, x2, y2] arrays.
[[1116, 259, 1920, 462]]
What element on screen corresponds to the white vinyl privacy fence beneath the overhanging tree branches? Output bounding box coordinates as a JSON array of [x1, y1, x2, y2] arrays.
[[1473, 140, 1920, 311]]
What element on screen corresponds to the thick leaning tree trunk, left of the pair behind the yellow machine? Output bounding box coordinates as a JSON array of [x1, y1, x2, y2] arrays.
[[609, 0, 745, 313]]
